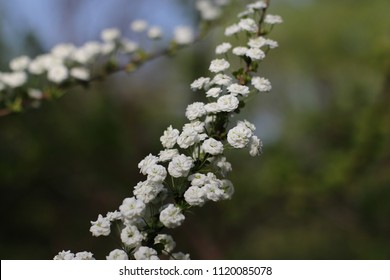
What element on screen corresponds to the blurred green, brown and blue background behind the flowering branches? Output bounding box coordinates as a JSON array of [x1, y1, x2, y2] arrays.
[[0, 0, 390, 259]]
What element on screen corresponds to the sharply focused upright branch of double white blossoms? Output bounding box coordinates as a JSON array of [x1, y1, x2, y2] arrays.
[[51, 1, 282, 260]]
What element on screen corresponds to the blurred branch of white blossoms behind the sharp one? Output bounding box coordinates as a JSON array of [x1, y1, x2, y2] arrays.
[[0, 0, 228, 116]]
